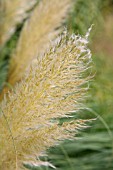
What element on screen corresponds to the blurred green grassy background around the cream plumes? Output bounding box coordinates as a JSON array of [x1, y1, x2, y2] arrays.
[[0, 0, 113, 170]]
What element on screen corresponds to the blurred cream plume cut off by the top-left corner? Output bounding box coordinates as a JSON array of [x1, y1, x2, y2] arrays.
[[0, 0, 36, 46]]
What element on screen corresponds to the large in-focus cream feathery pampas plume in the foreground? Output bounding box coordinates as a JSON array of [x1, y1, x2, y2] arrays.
[[0, 32, 91, 170]]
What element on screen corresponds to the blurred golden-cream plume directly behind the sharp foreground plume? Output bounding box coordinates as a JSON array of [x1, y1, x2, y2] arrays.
[[9, 0, 72, 85]]
